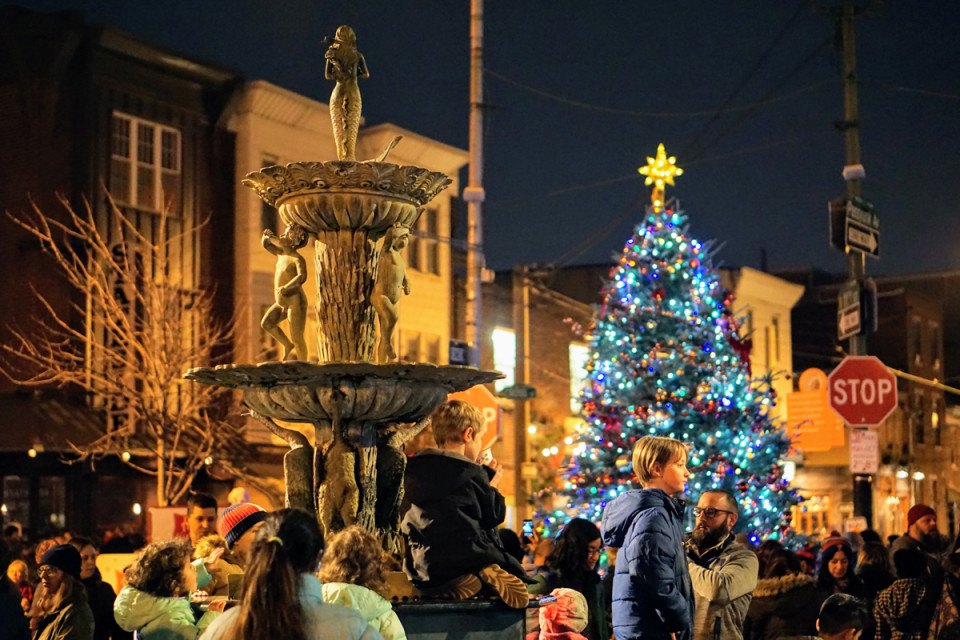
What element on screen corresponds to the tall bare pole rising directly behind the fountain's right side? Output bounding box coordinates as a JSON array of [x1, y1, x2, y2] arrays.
[[463, 0, 486, 367]]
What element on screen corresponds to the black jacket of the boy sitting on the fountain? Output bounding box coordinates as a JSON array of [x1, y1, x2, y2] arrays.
[[401, 449, 529, 589]]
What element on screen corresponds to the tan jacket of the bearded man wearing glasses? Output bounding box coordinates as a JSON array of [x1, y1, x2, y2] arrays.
[[687, 533, 758, 640]]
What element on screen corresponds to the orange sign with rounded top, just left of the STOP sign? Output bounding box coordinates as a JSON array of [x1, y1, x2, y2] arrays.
[[787, 369, 843, 451]]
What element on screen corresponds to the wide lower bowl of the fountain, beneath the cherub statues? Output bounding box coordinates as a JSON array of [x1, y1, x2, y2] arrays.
[[184, 362, 503, 425]]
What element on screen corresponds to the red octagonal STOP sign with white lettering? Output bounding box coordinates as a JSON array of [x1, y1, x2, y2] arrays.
[[828, 356, 897, 426]]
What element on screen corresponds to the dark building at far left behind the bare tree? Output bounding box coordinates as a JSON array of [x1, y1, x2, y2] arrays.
[[0, 7, 238, 534]]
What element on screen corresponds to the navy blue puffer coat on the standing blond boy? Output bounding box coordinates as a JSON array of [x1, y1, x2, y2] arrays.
[[601, 489, 694, 640]]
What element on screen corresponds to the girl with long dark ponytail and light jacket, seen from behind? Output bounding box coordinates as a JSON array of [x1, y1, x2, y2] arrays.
[[202, 509, 382, 640]]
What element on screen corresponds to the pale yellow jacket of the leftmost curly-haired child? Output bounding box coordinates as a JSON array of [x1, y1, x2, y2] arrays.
[[113, 585, 208, 640]]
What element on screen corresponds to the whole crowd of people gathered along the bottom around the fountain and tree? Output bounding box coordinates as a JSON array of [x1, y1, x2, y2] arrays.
[[0, 401, 960, 640]]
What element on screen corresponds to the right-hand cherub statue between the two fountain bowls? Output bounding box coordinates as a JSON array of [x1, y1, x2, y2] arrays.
[[372, 223, 410, 362]]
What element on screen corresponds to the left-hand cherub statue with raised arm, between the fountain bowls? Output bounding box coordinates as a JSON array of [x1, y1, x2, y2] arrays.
[[260, 224, 307, 360]]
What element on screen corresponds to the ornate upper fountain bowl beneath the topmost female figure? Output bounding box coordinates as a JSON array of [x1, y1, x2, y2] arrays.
[[243, 160, 452, 238]]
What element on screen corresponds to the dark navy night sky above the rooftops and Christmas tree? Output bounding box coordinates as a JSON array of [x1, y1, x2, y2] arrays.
[[20, 0, 960, 273]]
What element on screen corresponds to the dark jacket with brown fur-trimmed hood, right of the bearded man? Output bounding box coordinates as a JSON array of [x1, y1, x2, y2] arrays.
[[743, 573, 826, 640]]
